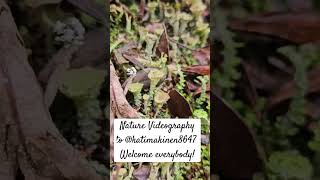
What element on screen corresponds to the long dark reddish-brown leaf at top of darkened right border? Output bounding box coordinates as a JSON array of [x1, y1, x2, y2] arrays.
[[230, 12, 320, 43]]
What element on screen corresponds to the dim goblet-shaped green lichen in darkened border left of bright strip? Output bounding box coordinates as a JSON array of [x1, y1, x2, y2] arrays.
[[59, 67, 106, 145]]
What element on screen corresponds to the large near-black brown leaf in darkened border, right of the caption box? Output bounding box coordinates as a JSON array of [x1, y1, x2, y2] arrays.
[[212, 92, 263, 179]]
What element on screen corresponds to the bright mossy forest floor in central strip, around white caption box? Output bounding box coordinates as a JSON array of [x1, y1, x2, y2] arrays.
[[110, 0, 210, 179]]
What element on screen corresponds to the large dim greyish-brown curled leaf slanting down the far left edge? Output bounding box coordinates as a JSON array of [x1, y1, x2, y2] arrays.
[[0, 0, 103, 180]]
